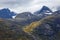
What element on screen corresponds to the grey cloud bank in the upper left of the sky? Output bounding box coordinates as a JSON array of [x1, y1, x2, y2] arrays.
[[0, 0, 31, 7]]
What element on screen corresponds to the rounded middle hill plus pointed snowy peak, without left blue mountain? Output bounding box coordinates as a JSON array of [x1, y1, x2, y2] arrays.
[[15, 6, 59, 25]]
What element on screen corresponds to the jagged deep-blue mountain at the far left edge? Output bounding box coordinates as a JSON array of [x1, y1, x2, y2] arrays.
[[0, 8, 16, 19]]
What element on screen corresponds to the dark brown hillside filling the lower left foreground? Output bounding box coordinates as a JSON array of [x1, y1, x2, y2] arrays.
[[0, 19, 34, 40]]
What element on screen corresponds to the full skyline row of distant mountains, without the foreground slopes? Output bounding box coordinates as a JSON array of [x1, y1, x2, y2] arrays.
[[0, 6, 60, 19]]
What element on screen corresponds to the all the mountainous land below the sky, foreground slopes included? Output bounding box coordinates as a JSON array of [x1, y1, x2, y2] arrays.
[[0, 6, 60, 40]]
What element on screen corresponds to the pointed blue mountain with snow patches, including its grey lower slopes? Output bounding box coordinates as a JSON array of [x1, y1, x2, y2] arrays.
[[34, 6, 53, 19]]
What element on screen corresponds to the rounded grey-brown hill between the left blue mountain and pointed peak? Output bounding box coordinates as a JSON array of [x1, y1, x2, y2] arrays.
[[15, 12, 40, 25]]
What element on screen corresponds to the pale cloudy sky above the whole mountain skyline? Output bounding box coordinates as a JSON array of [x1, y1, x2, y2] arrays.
[[0, 0, 60, 13]]
